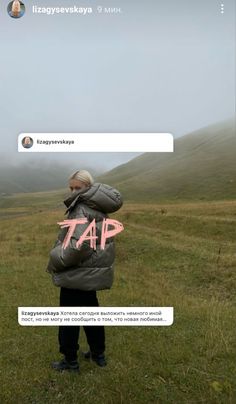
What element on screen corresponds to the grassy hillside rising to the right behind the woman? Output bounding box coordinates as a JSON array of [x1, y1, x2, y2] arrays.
[[99, 120, 236, 201]]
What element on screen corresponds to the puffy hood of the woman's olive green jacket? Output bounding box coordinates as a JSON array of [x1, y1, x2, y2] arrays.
[[64, 183, 123, 213]]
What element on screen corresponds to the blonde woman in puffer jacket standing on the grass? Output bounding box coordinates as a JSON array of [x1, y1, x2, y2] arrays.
[[47, 170, 123, 372]]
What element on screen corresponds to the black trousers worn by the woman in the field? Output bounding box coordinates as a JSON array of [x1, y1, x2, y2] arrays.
[[58, 288, 105, 360]]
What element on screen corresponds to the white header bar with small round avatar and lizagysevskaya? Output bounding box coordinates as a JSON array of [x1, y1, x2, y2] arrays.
[[18, 133, 174, 153]]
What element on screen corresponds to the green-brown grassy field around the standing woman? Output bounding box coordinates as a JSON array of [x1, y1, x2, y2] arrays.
[[0, 194, 236, 404]]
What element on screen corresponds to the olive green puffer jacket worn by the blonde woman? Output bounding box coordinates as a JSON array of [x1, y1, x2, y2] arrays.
[[47, 183, 123, 290]]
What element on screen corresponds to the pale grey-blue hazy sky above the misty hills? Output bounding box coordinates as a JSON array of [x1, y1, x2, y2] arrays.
[[0, 0, 235, 168]]
